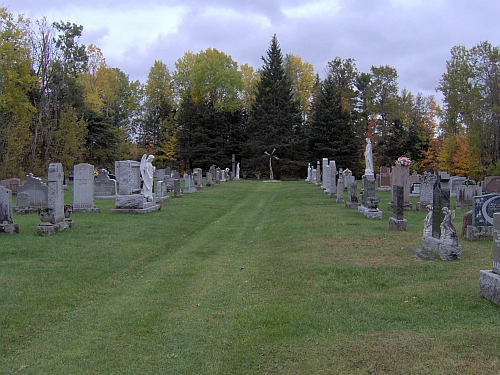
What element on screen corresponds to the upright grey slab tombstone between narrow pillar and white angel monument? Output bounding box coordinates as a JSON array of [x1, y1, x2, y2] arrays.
[[73, 163, 99, 212]]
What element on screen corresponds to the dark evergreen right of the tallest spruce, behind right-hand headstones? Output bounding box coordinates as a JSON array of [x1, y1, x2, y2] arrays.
[[309, 75, 361, 175]]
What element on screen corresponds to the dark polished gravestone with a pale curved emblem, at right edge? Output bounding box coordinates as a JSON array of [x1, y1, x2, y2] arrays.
[[465, 193, 500, 241]]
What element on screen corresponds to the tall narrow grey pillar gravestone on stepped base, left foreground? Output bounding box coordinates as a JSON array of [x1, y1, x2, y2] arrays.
[[36, 163, 73, 236]]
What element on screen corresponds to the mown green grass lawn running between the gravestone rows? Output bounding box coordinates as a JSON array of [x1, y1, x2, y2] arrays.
[[0, 180, 500, 374]]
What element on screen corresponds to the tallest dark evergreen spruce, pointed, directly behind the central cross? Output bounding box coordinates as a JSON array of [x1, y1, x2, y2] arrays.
[[242, 35, 305, 178]]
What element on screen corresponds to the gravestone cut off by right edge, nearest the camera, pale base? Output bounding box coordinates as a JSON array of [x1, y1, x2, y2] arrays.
[[479, 213, 500, 305]]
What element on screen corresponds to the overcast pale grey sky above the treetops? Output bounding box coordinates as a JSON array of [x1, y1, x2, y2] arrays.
[[6, 0, 500, 99]]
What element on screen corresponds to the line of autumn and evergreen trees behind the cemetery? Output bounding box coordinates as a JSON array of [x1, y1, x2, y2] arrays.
[[0, 8, 500, 179]]
